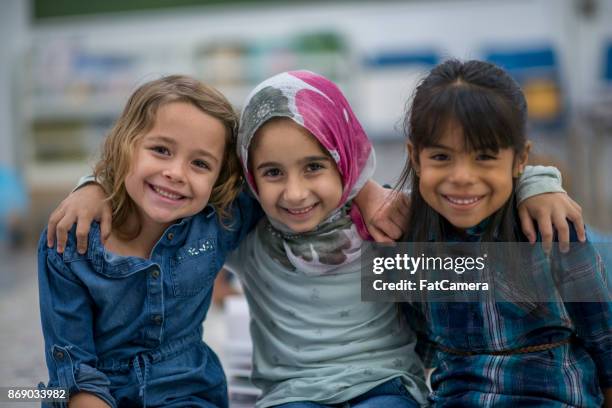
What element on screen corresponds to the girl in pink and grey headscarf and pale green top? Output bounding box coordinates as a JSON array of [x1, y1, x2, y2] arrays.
[[226, 71, 427, 408]]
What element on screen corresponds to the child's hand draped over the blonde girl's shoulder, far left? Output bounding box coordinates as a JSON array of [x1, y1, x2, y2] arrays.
[[47, 183, 111, 254]]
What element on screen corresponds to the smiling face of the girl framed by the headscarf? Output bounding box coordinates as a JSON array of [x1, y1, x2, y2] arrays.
[[250, 118, 342, 233]]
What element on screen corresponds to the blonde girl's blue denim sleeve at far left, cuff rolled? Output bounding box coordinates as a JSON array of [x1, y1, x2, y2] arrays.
[[38, 230, 116, 407]]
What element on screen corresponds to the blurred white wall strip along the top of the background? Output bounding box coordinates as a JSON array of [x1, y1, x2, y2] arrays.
[[28, 0, 612, 106]]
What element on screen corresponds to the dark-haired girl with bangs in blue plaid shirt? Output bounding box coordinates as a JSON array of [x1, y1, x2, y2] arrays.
[[400, 60, 612, 407]]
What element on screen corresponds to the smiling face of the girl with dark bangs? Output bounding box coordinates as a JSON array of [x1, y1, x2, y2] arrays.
[[408, 126, 529, 229]]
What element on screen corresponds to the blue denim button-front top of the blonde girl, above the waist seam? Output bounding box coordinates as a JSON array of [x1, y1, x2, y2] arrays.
[[38, 193, 262, 405]]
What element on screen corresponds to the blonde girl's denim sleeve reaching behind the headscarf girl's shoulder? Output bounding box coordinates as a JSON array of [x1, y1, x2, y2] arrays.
[[223, 190, 264, 251]]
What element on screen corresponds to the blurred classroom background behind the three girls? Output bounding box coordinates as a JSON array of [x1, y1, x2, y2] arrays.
[[0, 0, 612, 406]]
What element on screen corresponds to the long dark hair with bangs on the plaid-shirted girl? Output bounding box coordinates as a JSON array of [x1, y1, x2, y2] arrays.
[[397, 59, 527, 242]]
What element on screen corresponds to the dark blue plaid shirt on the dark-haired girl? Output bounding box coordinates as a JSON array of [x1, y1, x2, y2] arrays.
[[404, 225, 612, 407]]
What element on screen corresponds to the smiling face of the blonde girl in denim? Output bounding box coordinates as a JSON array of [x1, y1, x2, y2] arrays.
[[124, 102, 226, 230]]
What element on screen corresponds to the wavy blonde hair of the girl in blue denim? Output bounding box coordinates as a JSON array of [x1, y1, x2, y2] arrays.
[[94, 75, 242, 238]]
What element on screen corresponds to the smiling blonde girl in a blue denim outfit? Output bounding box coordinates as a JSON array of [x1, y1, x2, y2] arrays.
[[38, 76, 258, 408]]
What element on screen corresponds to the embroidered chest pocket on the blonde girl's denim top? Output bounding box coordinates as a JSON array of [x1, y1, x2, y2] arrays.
[[170, 237, 220, 298]]
